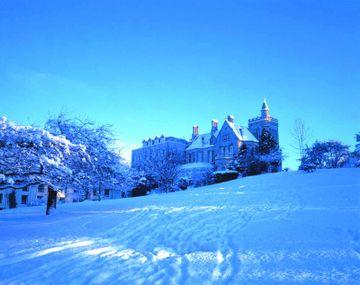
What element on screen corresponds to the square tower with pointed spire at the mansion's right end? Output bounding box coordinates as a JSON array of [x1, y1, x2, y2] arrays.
[[249, 99, 279, 144]]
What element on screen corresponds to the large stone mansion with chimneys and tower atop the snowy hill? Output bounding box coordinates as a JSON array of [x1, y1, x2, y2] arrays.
[[131, 100, 279, 170]]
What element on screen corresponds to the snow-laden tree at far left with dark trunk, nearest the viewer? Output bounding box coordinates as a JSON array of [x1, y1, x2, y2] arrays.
[[0, 117, 92, 211]]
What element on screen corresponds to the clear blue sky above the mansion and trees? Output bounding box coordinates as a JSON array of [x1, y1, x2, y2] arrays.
[[0, 0, 360, 168]]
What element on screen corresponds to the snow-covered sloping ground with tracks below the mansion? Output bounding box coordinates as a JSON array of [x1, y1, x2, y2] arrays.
[[0, 169, 360, 285]]
